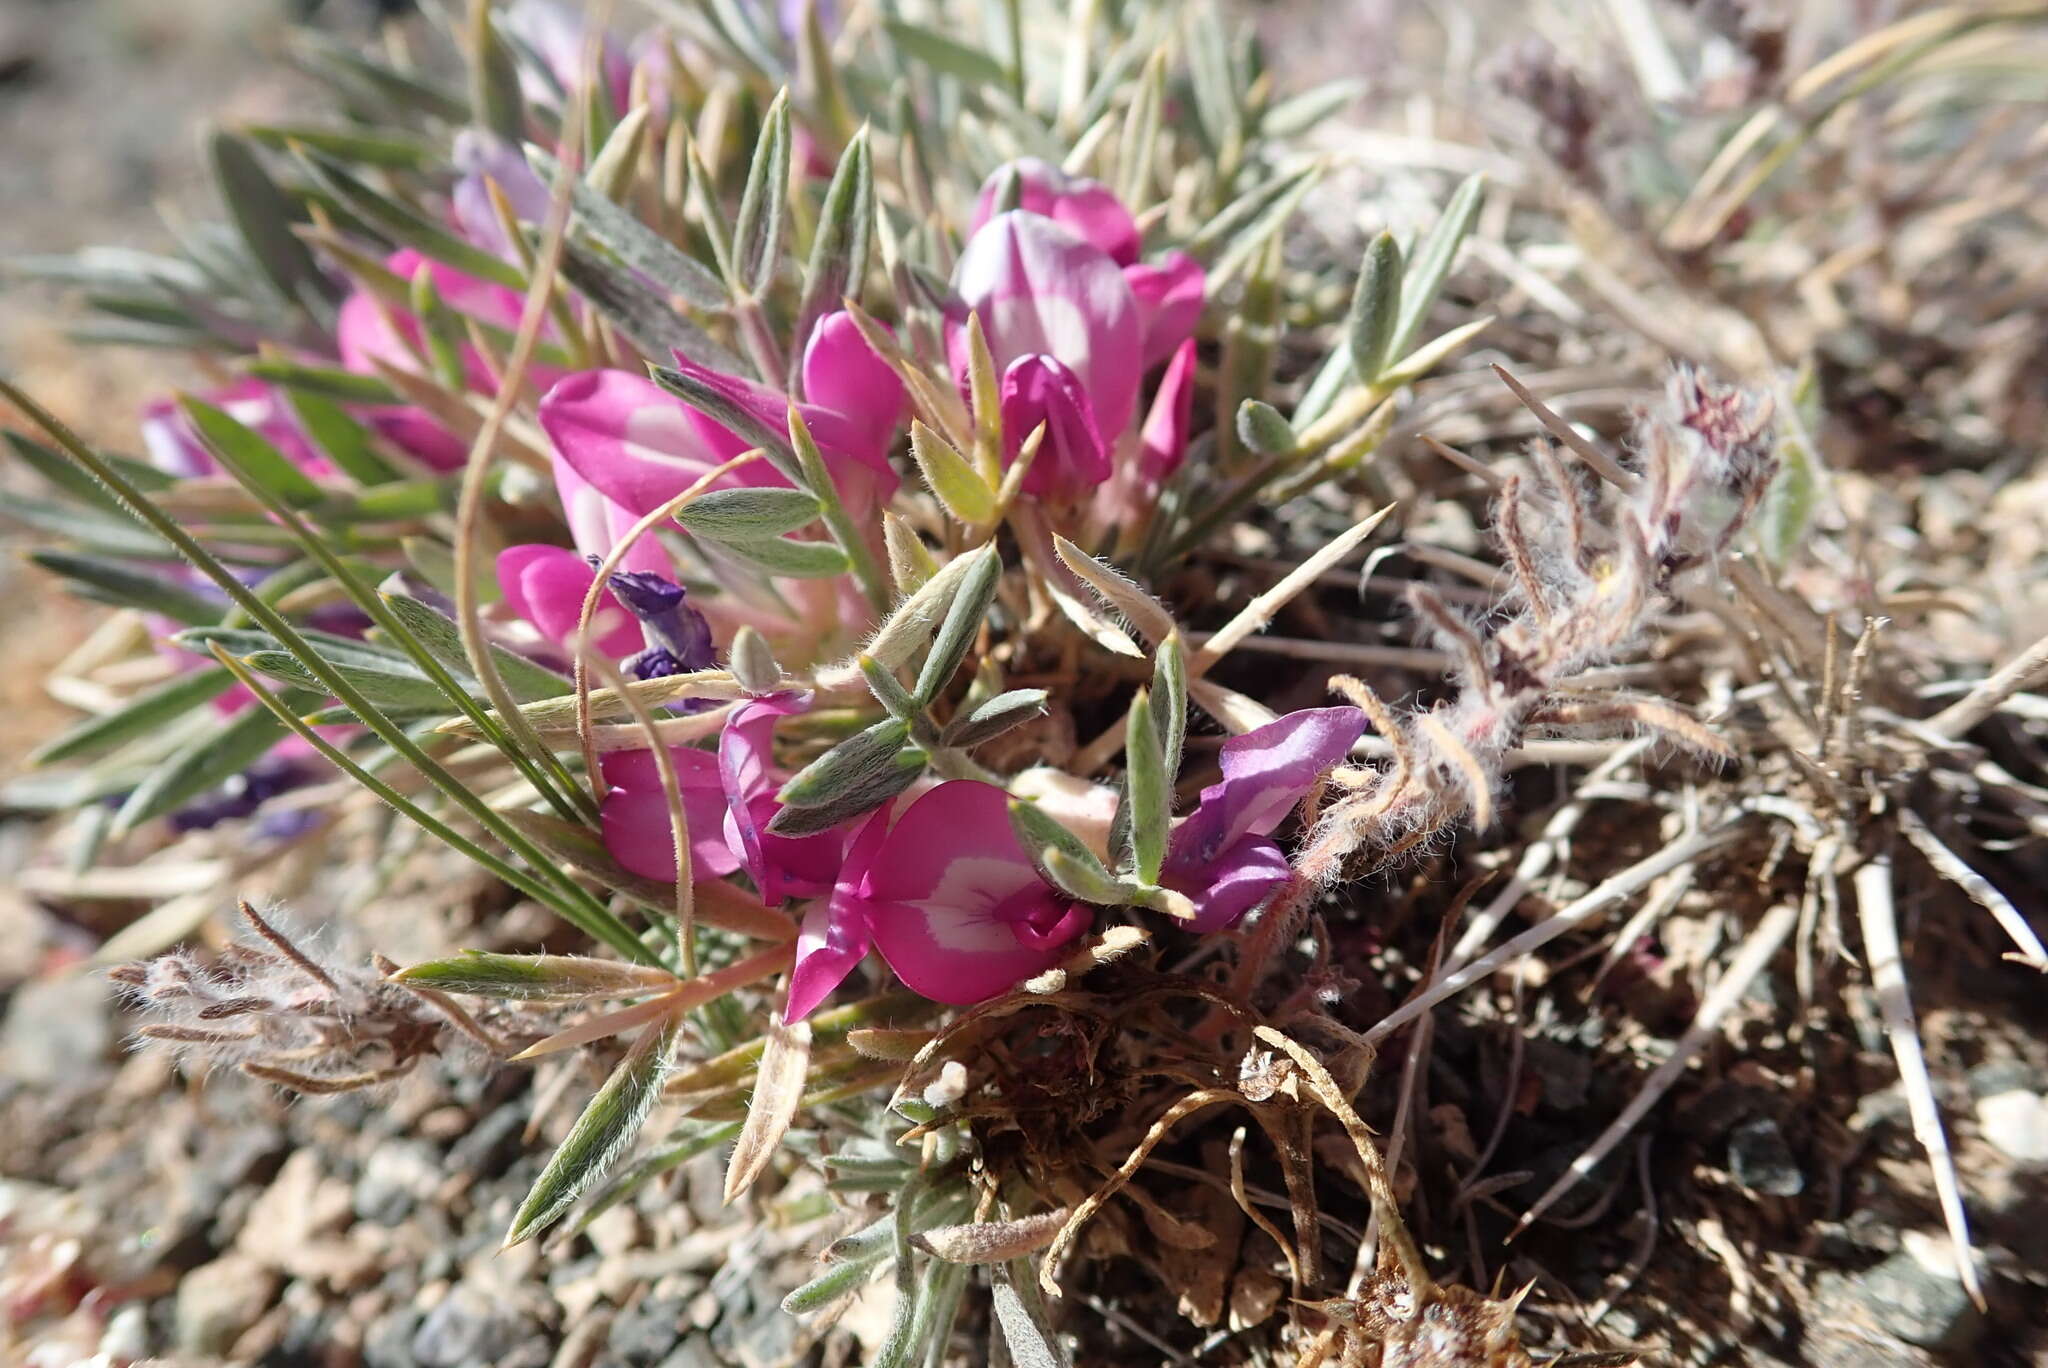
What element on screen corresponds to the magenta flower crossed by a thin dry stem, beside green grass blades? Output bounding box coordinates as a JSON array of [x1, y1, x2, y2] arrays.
[[598, 692, 848, 905]]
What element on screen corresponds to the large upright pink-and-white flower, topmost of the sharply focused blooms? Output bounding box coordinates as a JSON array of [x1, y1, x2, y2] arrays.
[[948, 178, 1204, 502]]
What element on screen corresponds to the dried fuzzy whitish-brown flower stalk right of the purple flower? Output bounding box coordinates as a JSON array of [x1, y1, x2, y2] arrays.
[[1298, 367, 1778, 883]]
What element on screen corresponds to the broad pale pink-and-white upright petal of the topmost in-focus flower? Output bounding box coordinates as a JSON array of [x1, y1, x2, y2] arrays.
[[950, 211, 1143, 444]]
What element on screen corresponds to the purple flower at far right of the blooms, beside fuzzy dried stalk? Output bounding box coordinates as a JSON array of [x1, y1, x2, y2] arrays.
[[1159, 709, 1366, 932]]
